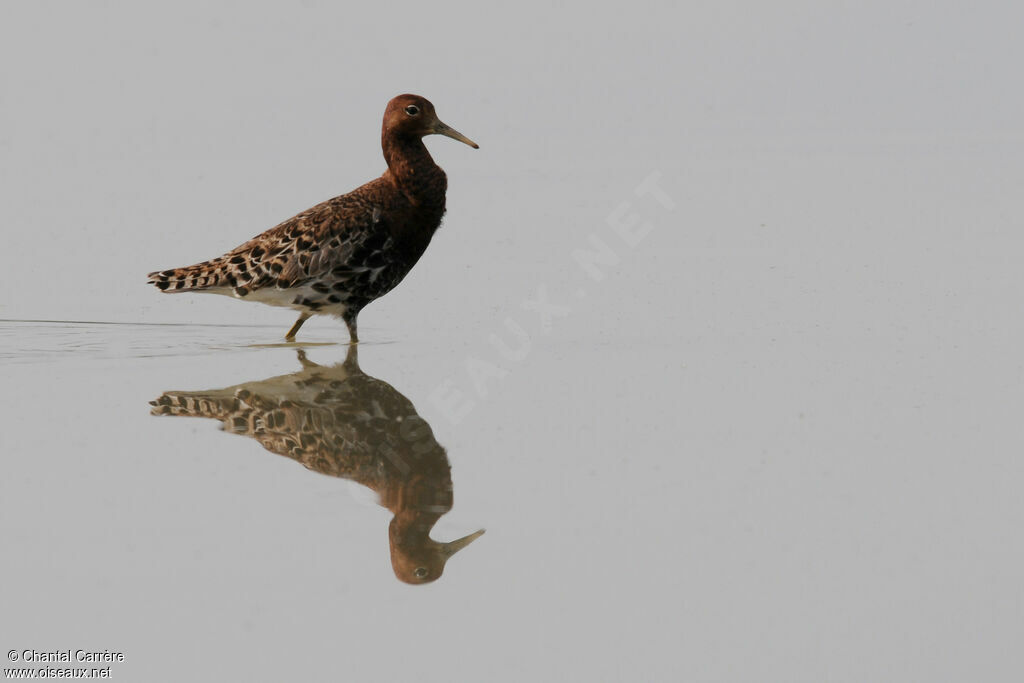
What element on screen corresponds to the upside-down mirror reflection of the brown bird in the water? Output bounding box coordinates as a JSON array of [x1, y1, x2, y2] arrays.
[[151, 346, 483, 584]]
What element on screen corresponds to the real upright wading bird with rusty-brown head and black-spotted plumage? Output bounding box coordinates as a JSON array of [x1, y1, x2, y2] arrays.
[[150, 95, 477, 342]]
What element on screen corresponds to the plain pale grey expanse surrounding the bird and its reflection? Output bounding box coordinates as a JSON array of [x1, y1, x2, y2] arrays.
[[0, 2, 1024, 682]]
